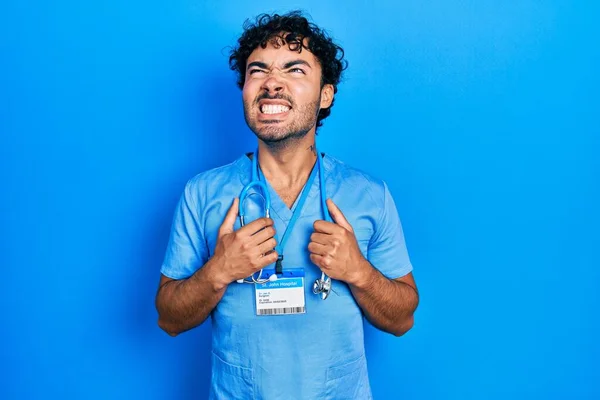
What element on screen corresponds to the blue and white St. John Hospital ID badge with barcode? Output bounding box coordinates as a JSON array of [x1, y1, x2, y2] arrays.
[[254, 268, 306, 315]]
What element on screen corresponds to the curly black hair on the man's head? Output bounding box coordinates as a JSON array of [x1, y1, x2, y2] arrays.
[[229, 11, 348, 128]]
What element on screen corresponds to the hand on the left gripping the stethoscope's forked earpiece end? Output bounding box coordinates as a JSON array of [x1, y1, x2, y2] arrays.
[[213, 198, 278, 285]]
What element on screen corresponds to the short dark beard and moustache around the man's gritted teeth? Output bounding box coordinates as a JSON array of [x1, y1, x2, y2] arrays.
[[244, 95, 321, 147]]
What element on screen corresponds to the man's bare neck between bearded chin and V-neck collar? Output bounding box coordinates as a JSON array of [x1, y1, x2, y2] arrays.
[[258, 134, 317, 188]]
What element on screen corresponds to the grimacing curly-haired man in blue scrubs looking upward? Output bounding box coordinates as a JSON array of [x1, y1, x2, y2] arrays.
[[156, 12, 418, 399]]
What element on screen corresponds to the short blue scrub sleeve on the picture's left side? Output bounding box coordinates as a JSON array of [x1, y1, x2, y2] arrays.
[[160, 180, 208, 279]]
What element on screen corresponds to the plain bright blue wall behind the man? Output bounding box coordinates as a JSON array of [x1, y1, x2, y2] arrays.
[[0, 0, 600, 399]]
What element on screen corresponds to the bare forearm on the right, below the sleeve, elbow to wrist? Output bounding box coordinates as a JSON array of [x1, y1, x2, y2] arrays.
[[349, 261, 419, 336]]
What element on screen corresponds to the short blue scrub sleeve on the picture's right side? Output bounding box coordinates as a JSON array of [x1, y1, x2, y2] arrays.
[[368, 183, 413, 279]]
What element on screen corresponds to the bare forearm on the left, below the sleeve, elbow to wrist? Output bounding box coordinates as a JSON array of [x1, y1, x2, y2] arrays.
[[156, 259, 227, 336]]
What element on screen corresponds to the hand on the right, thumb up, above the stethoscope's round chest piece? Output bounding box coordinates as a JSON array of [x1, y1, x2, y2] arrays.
[[308, 199, 370, 284]]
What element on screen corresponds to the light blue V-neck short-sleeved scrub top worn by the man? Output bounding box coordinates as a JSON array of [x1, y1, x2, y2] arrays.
[[161, 155, 412, 400]]
